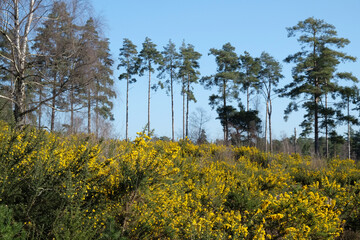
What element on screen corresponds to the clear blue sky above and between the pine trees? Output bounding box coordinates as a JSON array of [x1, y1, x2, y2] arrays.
[[91, 0, 360, 139]]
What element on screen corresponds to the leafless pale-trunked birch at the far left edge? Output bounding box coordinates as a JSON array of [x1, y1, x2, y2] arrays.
[[0, 0, 48, 125]]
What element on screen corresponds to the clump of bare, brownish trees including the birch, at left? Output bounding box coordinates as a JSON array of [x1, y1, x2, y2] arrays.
[[0, 0, 116, 135]]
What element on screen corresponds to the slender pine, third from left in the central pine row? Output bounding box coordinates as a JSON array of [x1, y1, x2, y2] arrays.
[[159, 40, 180, 141]]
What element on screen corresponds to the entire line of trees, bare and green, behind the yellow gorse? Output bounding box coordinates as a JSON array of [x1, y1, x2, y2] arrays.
[[0, 0, 360, 157]]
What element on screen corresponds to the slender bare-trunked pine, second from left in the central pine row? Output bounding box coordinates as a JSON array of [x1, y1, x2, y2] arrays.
[[139, 37, 163, 134]]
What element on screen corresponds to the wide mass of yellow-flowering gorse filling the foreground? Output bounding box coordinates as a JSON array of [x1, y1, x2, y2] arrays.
[[0, 124, 360, 239]]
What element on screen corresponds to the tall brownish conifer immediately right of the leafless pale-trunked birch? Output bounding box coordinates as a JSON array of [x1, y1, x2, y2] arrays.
[[33, 2, 76, 131]]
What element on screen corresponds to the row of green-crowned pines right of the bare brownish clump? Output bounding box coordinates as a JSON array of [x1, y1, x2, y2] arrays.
[[119, 18, 359, 160]]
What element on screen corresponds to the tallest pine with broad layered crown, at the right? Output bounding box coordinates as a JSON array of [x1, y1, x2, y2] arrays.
[[282, 18, 355, 155]]
